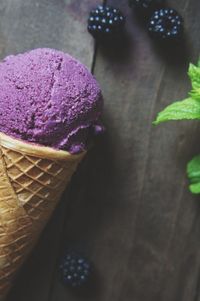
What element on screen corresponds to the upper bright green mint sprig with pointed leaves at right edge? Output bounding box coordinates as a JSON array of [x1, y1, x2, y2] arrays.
[[153, 60, 200, 125]]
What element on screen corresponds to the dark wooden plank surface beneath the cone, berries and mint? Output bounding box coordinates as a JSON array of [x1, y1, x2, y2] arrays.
[[0, 0, 200, 301]]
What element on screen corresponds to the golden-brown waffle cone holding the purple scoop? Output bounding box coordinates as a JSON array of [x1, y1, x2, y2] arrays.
[[0, 133, 84, 301]]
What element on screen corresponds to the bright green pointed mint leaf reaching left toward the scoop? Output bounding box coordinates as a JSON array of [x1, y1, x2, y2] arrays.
[[153, 98, 200, 125]]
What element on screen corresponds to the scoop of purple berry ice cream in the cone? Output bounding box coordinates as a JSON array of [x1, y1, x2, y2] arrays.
[[0, 48, 103, 153]]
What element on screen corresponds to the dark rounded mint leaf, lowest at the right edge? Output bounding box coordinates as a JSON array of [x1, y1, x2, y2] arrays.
[[187, 155, 200, 194]]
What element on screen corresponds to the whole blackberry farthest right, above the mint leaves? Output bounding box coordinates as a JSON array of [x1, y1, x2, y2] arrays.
[[148, 8, 183, 41]]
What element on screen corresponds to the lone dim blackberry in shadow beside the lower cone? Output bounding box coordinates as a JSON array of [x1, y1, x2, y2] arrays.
[[60, 252, 91, 287]]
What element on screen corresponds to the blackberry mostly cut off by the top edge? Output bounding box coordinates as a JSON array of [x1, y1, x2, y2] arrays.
[[129, 0, 165, 14]]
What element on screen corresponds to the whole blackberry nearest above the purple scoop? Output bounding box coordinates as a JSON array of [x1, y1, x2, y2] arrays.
[[88, 5, 125, 39]]
